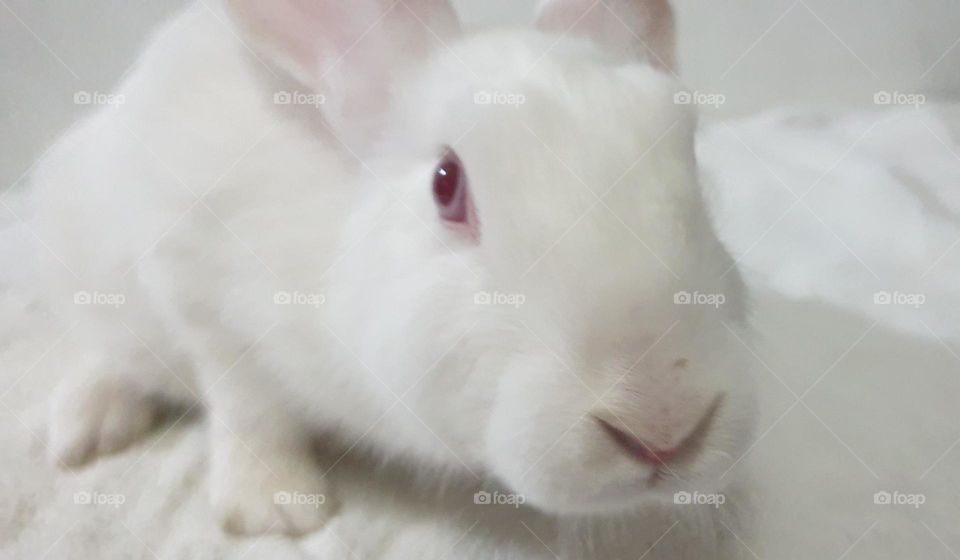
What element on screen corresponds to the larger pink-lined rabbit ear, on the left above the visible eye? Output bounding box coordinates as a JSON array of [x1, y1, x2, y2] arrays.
[[228, 0, 459, 147]]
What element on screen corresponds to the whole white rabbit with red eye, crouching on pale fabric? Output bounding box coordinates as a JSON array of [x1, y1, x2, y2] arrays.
[[34, 0, 753, 554]]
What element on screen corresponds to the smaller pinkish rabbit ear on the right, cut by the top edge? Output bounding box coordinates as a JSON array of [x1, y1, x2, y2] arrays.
[[537, 0, 676, 72]]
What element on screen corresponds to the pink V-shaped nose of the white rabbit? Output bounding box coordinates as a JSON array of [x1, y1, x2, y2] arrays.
[[593, 395, 723, 476]]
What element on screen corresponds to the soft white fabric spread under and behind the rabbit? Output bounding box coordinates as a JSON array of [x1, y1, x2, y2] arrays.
[[0, 107, 960, 560]]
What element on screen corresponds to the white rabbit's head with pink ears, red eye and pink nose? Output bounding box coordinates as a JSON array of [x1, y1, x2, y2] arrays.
[[233, 0, 753, 512]]
